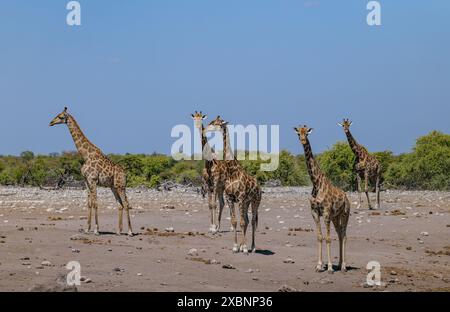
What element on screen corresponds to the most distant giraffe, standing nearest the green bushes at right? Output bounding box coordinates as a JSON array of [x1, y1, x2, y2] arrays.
[[338, 119, 382, 209]]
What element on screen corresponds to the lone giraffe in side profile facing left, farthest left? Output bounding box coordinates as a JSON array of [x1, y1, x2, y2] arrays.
[[50, 107, 133, 236]]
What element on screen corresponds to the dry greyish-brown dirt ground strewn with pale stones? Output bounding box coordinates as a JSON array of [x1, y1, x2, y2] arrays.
[[0, 187, 450, 292]]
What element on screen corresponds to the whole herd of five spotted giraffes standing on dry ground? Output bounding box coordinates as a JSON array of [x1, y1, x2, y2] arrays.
[[50, 107, 381, 273]]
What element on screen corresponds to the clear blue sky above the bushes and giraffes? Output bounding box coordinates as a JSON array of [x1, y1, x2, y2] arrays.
[[0, 0, 450, 154]]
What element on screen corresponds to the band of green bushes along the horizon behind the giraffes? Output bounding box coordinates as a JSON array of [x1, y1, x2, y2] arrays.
[[0, 131, 450, 190]]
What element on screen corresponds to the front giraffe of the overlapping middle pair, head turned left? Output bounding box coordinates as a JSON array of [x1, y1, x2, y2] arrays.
[[207, 116, 262, 254]]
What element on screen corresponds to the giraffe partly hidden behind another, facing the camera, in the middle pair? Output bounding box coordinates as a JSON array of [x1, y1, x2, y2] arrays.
[[191, 111, 225, 234]]
